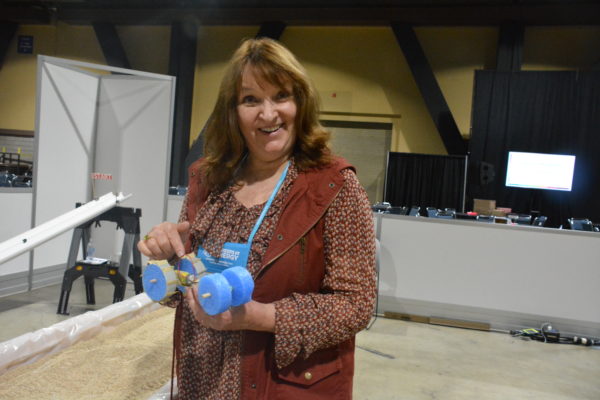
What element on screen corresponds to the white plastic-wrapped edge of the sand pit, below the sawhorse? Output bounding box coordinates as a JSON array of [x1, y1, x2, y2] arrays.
[[0, 293, 160, 375]]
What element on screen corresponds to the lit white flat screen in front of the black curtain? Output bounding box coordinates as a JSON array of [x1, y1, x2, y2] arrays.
[[506, 151, 575, 191]]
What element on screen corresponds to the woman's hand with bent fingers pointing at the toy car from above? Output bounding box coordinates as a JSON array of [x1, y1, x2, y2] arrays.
[[138, 221, 190, 260]]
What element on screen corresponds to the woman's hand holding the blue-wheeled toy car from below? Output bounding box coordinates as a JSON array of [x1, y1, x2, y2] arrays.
[[185, 286, 275, 332]]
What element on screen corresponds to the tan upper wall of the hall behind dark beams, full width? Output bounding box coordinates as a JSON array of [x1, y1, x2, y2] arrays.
[[0, 23, 600, 154]]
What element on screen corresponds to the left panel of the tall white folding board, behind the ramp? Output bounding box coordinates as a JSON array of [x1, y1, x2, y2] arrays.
[[33, 59, 98, 269]]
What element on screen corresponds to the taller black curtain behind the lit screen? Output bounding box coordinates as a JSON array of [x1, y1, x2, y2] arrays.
[[468, 71, 600, 226]]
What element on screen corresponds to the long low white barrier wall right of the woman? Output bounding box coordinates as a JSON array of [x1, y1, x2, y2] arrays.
[[379, 216, 600, 323]]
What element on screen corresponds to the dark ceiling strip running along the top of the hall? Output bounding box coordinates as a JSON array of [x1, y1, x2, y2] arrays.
[[0, 0, 600, 25]]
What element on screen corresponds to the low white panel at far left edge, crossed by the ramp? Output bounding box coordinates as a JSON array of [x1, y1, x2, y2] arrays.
[[0, 191, 33, 276]]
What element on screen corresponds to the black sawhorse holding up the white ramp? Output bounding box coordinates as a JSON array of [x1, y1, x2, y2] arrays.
[[56, 203, 144, 315]]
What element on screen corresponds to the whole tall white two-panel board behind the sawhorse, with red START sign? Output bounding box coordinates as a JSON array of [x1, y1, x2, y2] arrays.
[[30, 56, 175, 270]]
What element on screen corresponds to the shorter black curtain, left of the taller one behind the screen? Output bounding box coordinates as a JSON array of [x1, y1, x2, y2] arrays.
[[383, 152, 466, 211]]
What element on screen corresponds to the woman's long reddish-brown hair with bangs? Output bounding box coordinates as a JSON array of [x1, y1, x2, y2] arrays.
[[203, 38, 331, 190]]
